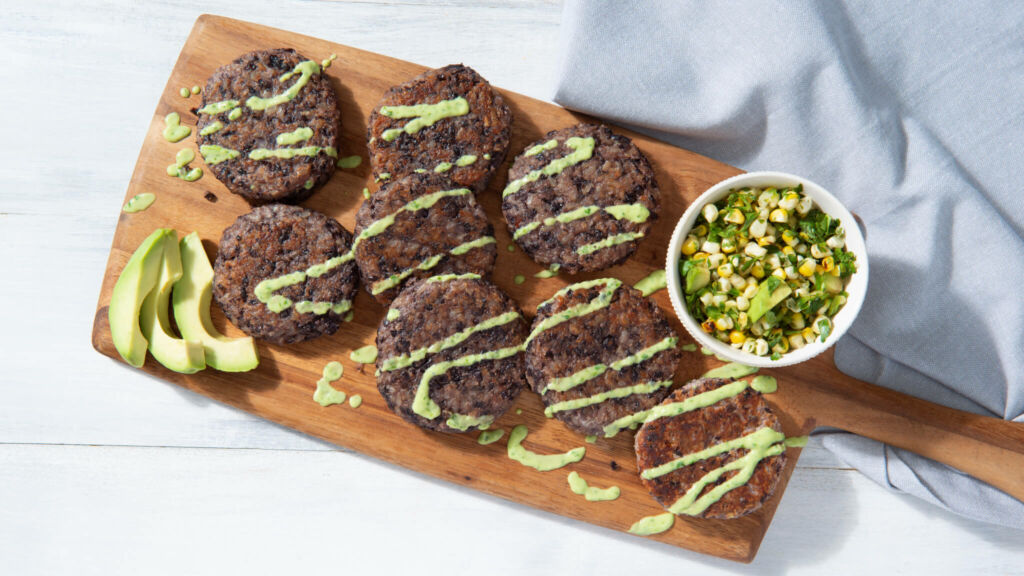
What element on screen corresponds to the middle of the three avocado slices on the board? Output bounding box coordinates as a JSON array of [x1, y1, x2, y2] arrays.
[[138, 231, 206, 374]]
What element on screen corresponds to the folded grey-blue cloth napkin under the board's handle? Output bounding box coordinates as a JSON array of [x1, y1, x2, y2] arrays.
[[555, 0, 1024, 528]]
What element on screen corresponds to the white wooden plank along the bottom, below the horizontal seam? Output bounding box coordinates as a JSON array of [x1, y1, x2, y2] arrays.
[[0, 446, 1024, 576]]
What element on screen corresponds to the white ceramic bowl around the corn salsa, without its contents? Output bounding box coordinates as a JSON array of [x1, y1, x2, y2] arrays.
[[665, 172, 867, 368]]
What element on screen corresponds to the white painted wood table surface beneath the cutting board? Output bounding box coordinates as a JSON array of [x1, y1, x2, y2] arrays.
[[0, 0, 1024, 576]]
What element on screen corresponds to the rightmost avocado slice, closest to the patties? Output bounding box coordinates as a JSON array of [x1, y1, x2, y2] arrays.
[[171, 232, 259, 372]]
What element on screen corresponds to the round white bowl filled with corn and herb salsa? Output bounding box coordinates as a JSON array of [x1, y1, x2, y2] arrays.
[[667, 172, 866, 367]]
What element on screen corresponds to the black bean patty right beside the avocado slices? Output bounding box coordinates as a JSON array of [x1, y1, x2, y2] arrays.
[[213, 204, 357, 344]]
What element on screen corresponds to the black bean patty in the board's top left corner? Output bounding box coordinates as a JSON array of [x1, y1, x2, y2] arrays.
[[196, 49, 340, 204]]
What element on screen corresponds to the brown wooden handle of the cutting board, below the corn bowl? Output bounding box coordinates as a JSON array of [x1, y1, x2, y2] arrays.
[[779, 351, 1024, 501]]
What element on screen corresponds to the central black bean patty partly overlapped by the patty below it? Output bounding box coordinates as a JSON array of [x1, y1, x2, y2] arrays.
[[355, 173, 498, 304]]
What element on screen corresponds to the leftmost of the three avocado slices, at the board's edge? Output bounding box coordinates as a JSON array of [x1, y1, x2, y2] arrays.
[[106, 229, 174, 368]]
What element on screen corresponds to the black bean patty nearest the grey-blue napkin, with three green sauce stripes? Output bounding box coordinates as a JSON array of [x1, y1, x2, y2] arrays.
[[502, 124, 660, 274]]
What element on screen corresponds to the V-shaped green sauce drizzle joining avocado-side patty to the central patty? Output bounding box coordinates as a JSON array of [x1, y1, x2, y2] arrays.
[[254, 187, 472, 315]]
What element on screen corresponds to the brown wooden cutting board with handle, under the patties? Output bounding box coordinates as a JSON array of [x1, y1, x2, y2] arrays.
[[92, 15, 1024, 562]]
